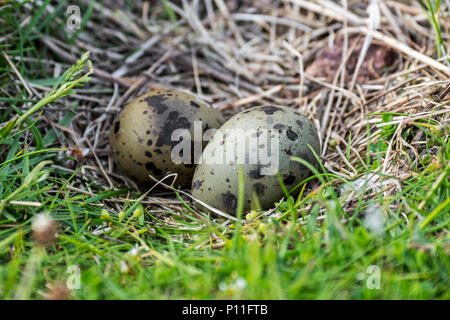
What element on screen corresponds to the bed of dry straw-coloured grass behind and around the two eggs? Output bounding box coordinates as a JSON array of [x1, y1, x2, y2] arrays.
[[13, 1, 450, 215]]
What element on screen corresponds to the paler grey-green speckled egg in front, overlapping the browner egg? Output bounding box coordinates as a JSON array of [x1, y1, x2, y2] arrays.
[[192, 105, 320, 214]]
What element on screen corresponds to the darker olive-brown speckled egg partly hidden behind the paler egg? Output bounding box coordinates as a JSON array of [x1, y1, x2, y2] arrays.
[[110, 90, 225, 187]]
